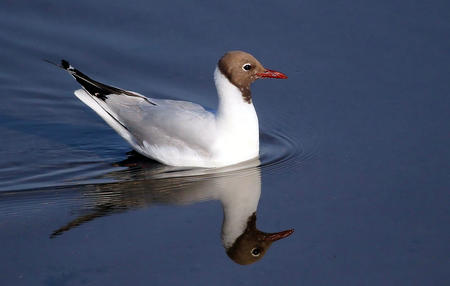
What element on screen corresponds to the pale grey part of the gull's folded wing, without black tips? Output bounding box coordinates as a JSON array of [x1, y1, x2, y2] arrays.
[[107, 97, 215, 150]]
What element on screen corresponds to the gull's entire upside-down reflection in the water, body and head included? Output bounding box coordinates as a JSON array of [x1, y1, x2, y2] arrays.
[[51, 153, 293, 265]]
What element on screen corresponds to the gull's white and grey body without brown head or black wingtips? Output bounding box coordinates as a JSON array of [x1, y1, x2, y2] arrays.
[[75, 68, 259, 167]]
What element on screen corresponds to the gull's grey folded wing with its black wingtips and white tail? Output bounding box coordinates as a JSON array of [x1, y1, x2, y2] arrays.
[[62, 60, 216, 160]]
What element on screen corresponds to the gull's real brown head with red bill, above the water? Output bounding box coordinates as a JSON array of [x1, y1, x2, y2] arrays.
[[217, 51, 287, 103]]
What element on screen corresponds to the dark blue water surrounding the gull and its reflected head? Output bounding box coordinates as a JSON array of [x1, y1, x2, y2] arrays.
[[0, 0, 450, 285]]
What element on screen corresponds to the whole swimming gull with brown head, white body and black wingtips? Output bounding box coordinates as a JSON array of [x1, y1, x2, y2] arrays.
[[60, 51, 287, 168]]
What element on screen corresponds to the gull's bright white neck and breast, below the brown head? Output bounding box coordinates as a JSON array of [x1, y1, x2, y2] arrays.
[[214, 67, 259, 163]]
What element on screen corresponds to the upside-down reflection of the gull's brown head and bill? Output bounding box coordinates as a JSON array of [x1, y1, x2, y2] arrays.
[[227, 213, 294, 265]]
